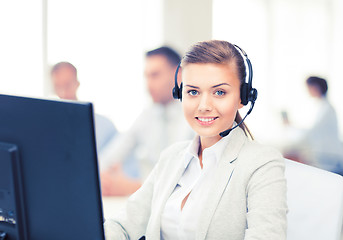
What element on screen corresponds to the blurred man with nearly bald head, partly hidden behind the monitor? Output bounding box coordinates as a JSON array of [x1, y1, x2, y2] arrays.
[[51, 62, 117, 153]]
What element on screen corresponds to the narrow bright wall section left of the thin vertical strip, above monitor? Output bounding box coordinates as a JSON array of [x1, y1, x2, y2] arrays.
[[0, 0, 43, 96]]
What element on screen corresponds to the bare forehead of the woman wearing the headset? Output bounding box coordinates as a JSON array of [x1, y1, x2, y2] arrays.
[[182, 62, 240, 86]]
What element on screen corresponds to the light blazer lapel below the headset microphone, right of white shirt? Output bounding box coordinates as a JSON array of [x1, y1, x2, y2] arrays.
[[196, 128, 246, 240]]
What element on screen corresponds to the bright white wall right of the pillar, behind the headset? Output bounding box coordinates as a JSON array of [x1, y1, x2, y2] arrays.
[[213, 0, 343, 139]]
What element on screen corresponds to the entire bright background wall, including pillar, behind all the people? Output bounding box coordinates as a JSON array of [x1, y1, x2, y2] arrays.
[[0, 0, 343, 142]]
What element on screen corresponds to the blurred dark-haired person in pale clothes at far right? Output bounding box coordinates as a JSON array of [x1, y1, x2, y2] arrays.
[[284, 76, 343, 174]]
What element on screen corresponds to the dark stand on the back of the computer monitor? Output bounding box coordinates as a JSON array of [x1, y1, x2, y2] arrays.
[[0, 142, 27, 240]]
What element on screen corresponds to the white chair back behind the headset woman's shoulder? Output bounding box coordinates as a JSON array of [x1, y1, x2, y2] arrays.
[[285, 159, 343, 240]]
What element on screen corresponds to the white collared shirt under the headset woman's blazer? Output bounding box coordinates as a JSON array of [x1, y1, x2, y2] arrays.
[[161, 135, 234, 240]]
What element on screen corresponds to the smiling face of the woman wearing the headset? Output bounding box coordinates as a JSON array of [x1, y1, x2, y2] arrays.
[[182, 62, 243, 145]]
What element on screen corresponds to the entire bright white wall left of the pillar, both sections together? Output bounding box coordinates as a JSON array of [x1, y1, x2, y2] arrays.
[[0, 0, 163, 131]]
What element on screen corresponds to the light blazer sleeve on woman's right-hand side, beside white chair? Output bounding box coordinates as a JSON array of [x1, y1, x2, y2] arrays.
[[244, 157, 287, 240]]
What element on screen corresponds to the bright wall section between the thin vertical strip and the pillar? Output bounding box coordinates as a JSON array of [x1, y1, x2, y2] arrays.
[[48, 0, 165, 130]]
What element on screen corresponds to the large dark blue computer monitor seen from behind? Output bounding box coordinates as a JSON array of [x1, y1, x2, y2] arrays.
[[0, 95, 104, 240]]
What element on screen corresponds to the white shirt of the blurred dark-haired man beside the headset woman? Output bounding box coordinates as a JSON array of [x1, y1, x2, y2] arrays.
[[99, 101, 194, 180]]
